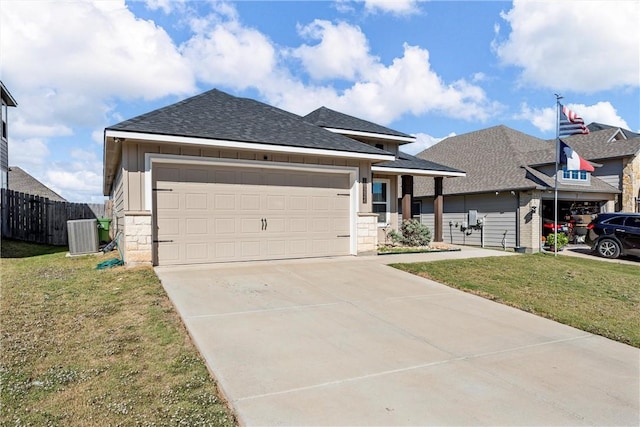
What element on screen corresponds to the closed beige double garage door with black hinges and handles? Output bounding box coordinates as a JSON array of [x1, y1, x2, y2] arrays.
[[152, 164, 350, 265]]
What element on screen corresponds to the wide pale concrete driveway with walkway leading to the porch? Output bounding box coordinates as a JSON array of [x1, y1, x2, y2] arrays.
[[156, 249, 640, 426]]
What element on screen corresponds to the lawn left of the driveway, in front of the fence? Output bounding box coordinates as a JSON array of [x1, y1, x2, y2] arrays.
[[0, 240, 235, 426]]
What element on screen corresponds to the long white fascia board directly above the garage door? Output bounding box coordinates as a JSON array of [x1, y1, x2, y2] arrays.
[[105, 130, 395, 161]]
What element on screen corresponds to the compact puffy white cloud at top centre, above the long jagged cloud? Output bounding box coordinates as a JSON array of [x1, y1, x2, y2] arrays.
[[291, 19, 378, 80]]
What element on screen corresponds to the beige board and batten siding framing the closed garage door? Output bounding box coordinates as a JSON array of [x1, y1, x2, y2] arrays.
[[114, 141, 371, 212]]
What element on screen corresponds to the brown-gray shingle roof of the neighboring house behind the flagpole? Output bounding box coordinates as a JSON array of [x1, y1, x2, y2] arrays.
[[414, 125, 624, 196]]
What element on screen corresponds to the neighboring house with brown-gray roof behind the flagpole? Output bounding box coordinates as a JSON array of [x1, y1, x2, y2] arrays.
[[414, 124, 640, 252]]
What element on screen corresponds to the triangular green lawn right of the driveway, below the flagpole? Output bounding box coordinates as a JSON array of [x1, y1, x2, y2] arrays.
[[393, 254, 640, 347]]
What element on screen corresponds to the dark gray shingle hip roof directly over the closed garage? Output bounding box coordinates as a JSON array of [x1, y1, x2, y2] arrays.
[[106, 89, 390, 155]]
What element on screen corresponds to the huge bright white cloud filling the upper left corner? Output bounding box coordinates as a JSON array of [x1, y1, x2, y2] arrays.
[[0, 0, 195, 130]]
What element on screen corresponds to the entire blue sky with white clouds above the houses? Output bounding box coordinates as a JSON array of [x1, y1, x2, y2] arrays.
[[0, 0, 640, 202]]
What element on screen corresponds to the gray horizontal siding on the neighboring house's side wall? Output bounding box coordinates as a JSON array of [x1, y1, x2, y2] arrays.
[[416, 192, 517, 248]]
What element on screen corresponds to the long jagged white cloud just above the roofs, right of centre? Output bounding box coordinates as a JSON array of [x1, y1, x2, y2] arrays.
[[276, 40, 501, 124]]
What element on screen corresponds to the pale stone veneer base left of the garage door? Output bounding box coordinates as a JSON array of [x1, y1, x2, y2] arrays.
[[121, 211, 153, 266]]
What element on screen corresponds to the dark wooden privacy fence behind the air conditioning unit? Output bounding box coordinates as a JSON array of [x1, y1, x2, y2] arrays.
[[1, 189, 105, 246]]
